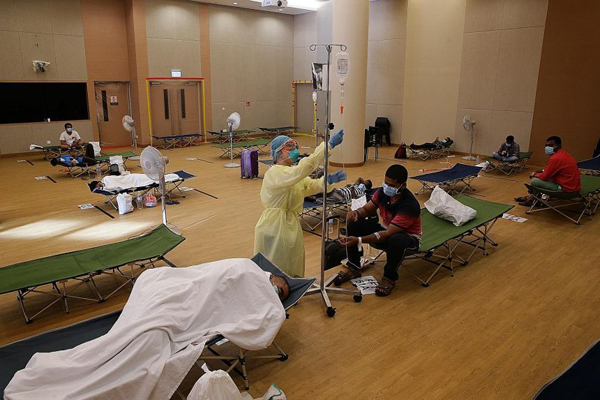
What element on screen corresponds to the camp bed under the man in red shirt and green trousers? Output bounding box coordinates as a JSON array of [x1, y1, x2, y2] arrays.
[[525, 175, 600, 225]]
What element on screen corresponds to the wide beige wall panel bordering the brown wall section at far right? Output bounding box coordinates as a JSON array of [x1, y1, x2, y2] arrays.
[[455, 0, 548, 155]]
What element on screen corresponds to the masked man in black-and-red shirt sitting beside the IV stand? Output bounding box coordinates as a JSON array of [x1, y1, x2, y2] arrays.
[[334, 164, 421, 296]]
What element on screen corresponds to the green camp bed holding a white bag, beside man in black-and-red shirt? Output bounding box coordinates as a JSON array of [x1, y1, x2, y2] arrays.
[[367, 194, 514, 287]]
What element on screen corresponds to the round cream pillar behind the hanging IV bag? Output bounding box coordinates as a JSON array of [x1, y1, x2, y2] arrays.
[[330, 0, 369, 167]]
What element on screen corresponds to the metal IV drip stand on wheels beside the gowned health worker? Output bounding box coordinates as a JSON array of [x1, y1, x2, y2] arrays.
[[306, 44, 362, 317]]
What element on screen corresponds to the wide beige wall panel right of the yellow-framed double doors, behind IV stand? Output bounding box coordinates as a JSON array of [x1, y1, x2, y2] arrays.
[[210, 5, 294, 129]]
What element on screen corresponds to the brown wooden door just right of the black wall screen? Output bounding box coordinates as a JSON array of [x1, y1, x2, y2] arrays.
[[94, 82, 132, 146]]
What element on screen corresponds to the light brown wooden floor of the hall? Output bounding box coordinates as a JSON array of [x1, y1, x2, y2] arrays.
[[0, 139, 600, 399]]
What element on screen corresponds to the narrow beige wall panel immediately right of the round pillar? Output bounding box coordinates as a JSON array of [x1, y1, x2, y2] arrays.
[[366, 0, 408, 143]]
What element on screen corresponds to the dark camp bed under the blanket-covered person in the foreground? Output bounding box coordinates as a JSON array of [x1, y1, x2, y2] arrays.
[[0, 253, 315, 393]]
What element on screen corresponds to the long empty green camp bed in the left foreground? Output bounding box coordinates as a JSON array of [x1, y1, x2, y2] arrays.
[[0, 225, 185, 323]]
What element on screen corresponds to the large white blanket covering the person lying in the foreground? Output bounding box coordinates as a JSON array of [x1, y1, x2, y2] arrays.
[[4, 258, 285, 400]]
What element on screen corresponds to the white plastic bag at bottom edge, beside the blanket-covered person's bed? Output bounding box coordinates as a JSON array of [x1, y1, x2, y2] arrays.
[[187, 364, 242, 400]]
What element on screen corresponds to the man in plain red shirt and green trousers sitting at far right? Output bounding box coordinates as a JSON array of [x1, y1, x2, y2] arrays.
[[515, 136, 581, 207]]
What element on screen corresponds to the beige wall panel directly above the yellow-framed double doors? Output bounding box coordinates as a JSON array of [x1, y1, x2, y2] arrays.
[[146, 0, 202, 78]]
